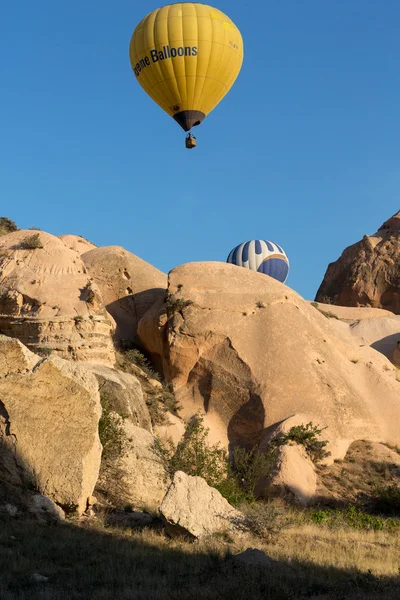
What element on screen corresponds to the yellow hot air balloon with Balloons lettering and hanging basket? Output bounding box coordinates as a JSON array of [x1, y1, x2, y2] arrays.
[[130, 2, 243, 148]]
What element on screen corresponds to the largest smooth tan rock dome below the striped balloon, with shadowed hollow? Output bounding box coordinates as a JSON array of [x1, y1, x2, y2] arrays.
[[140, 263, 400, 463]]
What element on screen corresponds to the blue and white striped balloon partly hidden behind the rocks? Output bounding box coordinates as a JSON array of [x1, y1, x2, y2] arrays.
[[226, 240, 289, 283]]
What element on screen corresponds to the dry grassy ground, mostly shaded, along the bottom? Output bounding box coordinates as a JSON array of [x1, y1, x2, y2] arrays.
[[0, 509, 400, 600]]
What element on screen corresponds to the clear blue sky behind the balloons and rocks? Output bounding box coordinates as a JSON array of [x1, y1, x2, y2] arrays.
[[0, 0, 400, 299]]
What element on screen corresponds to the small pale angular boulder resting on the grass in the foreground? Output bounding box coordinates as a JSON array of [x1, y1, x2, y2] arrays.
[[160, 471, 245, 538]]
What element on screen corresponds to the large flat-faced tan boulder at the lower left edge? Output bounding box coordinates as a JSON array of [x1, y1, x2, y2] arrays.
[[0, 337, 101, 513]]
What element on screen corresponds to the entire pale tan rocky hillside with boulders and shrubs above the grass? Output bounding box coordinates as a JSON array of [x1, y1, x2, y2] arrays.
[[0, 221, 400, 548]]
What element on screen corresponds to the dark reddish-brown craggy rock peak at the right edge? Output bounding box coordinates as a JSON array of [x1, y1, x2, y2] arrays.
[[315, 211, 400, 314]]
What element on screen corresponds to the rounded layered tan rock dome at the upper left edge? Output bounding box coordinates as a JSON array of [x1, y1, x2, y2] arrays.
[[0, 231, 115, 363]]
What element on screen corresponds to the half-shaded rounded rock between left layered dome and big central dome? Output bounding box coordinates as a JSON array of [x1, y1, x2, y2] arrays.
[[82, 246, 167, 344]]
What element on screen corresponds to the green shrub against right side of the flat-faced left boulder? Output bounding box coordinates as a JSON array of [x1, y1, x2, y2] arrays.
[[99, 392, 126, 459]]
